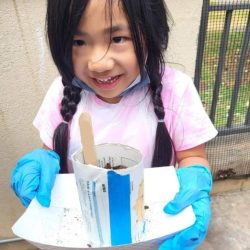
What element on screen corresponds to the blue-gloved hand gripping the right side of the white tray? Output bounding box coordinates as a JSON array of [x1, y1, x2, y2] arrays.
[[159, 165, 212, 250]]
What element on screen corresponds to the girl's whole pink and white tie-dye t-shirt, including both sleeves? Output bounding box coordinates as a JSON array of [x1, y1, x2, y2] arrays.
[[33, 67, 217, 172]]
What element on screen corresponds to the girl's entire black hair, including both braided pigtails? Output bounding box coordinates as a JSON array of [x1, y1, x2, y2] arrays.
[[46, 0, 173, 173]]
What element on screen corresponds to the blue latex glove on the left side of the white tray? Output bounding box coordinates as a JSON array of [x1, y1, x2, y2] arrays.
[[11, 148, 60, 207]]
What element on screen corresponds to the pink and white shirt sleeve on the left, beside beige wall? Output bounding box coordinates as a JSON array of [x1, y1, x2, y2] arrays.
[[33, 77, 63, 148]]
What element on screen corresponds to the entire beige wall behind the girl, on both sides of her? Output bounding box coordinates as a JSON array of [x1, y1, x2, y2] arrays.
[[0, 0, 202, 239]]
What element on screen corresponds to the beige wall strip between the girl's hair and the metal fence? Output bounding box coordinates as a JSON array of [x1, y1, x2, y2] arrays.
[[166, 0, 203, 77]]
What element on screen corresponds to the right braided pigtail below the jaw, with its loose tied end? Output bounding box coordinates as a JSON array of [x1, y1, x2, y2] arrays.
[[151, 68, 173, 167]]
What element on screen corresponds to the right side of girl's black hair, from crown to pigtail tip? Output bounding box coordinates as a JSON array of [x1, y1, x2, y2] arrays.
[[118, 0, 174, 167]]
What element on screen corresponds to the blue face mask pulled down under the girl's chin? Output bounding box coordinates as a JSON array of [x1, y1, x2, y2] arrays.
[[72, 69, 150, 97]]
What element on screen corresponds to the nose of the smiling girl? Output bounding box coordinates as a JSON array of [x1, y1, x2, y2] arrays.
[[88, 51, 114, 73]]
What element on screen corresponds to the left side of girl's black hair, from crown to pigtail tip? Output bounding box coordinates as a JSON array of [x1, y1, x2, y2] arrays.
[[46, 0, 89, 173]]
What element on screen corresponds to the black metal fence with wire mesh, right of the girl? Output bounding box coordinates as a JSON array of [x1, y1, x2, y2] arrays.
[[194, 0, 250, 179]]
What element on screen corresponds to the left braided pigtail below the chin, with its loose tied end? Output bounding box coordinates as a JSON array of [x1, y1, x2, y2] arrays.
[[53, 78, 81, 173]]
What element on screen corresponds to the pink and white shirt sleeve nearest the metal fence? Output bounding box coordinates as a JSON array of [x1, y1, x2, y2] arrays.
[[162, 69, 218, 151]]
